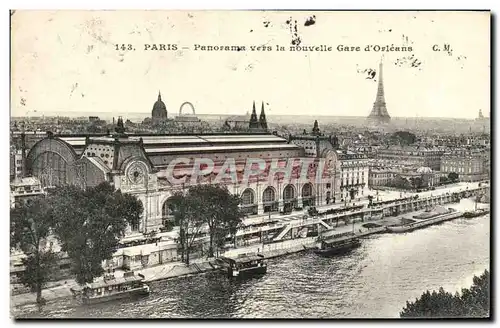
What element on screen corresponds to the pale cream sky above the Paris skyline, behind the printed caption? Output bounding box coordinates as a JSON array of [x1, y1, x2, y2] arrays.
[[11, 10, 490, 118]]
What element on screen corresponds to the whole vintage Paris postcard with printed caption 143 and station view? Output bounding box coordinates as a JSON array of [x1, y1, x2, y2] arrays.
[[10, 10, 491, 319]]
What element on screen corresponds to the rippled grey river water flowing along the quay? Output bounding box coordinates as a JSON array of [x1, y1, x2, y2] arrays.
[[14, 201, 490, 318]]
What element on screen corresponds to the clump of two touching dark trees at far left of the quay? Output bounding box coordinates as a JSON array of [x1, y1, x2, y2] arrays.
[[10, 183, 143, 304]]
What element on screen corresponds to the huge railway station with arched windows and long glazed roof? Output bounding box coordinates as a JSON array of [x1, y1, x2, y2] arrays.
[[25, 99, 364, 233]]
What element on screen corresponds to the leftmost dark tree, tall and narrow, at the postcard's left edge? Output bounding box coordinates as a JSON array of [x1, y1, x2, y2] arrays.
[[10, 198, 57, 306]]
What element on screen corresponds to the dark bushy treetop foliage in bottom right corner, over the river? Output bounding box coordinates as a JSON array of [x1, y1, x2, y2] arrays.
[[400, 270, 490, 318]]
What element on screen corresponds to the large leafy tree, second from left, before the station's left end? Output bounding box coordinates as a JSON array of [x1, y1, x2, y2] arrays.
[[50, 182, 143, 284]]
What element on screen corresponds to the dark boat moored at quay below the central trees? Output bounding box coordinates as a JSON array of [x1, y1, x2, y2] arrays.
[[216, 254, 267, 277]]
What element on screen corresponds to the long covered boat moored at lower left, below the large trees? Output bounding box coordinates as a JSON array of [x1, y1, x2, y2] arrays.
[[71, 272, 150, 304]]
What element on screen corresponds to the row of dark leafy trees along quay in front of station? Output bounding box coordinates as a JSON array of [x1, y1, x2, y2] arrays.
[[10, 183, 243, 304]]
